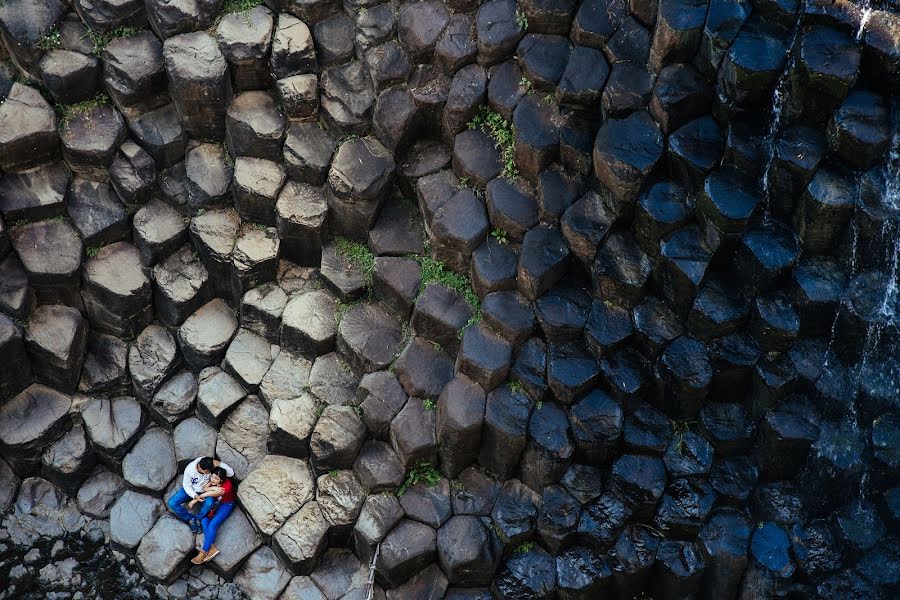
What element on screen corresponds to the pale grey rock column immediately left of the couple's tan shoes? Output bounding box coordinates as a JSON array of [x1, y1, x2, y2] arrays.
[[137, 514, 194, 585]]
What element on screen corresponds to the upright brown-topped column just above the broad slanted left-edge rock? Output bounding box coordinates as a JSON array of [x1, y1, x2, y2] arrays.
[[25, 304, 87, 392]]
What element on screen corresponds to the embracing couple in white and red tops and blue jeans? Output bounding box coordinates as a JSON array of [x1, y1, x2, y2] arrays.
[[169, 456, 237, 565]]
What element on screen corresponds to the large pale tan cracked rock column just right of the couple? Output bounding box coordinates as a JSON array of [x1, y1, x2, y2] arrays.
[[238, 455, 315, 536]]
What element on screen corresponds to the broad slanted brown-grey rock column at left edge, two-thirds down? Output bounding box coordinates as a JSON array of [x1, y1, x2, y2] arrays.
[[0, 383, 72, 475]]
